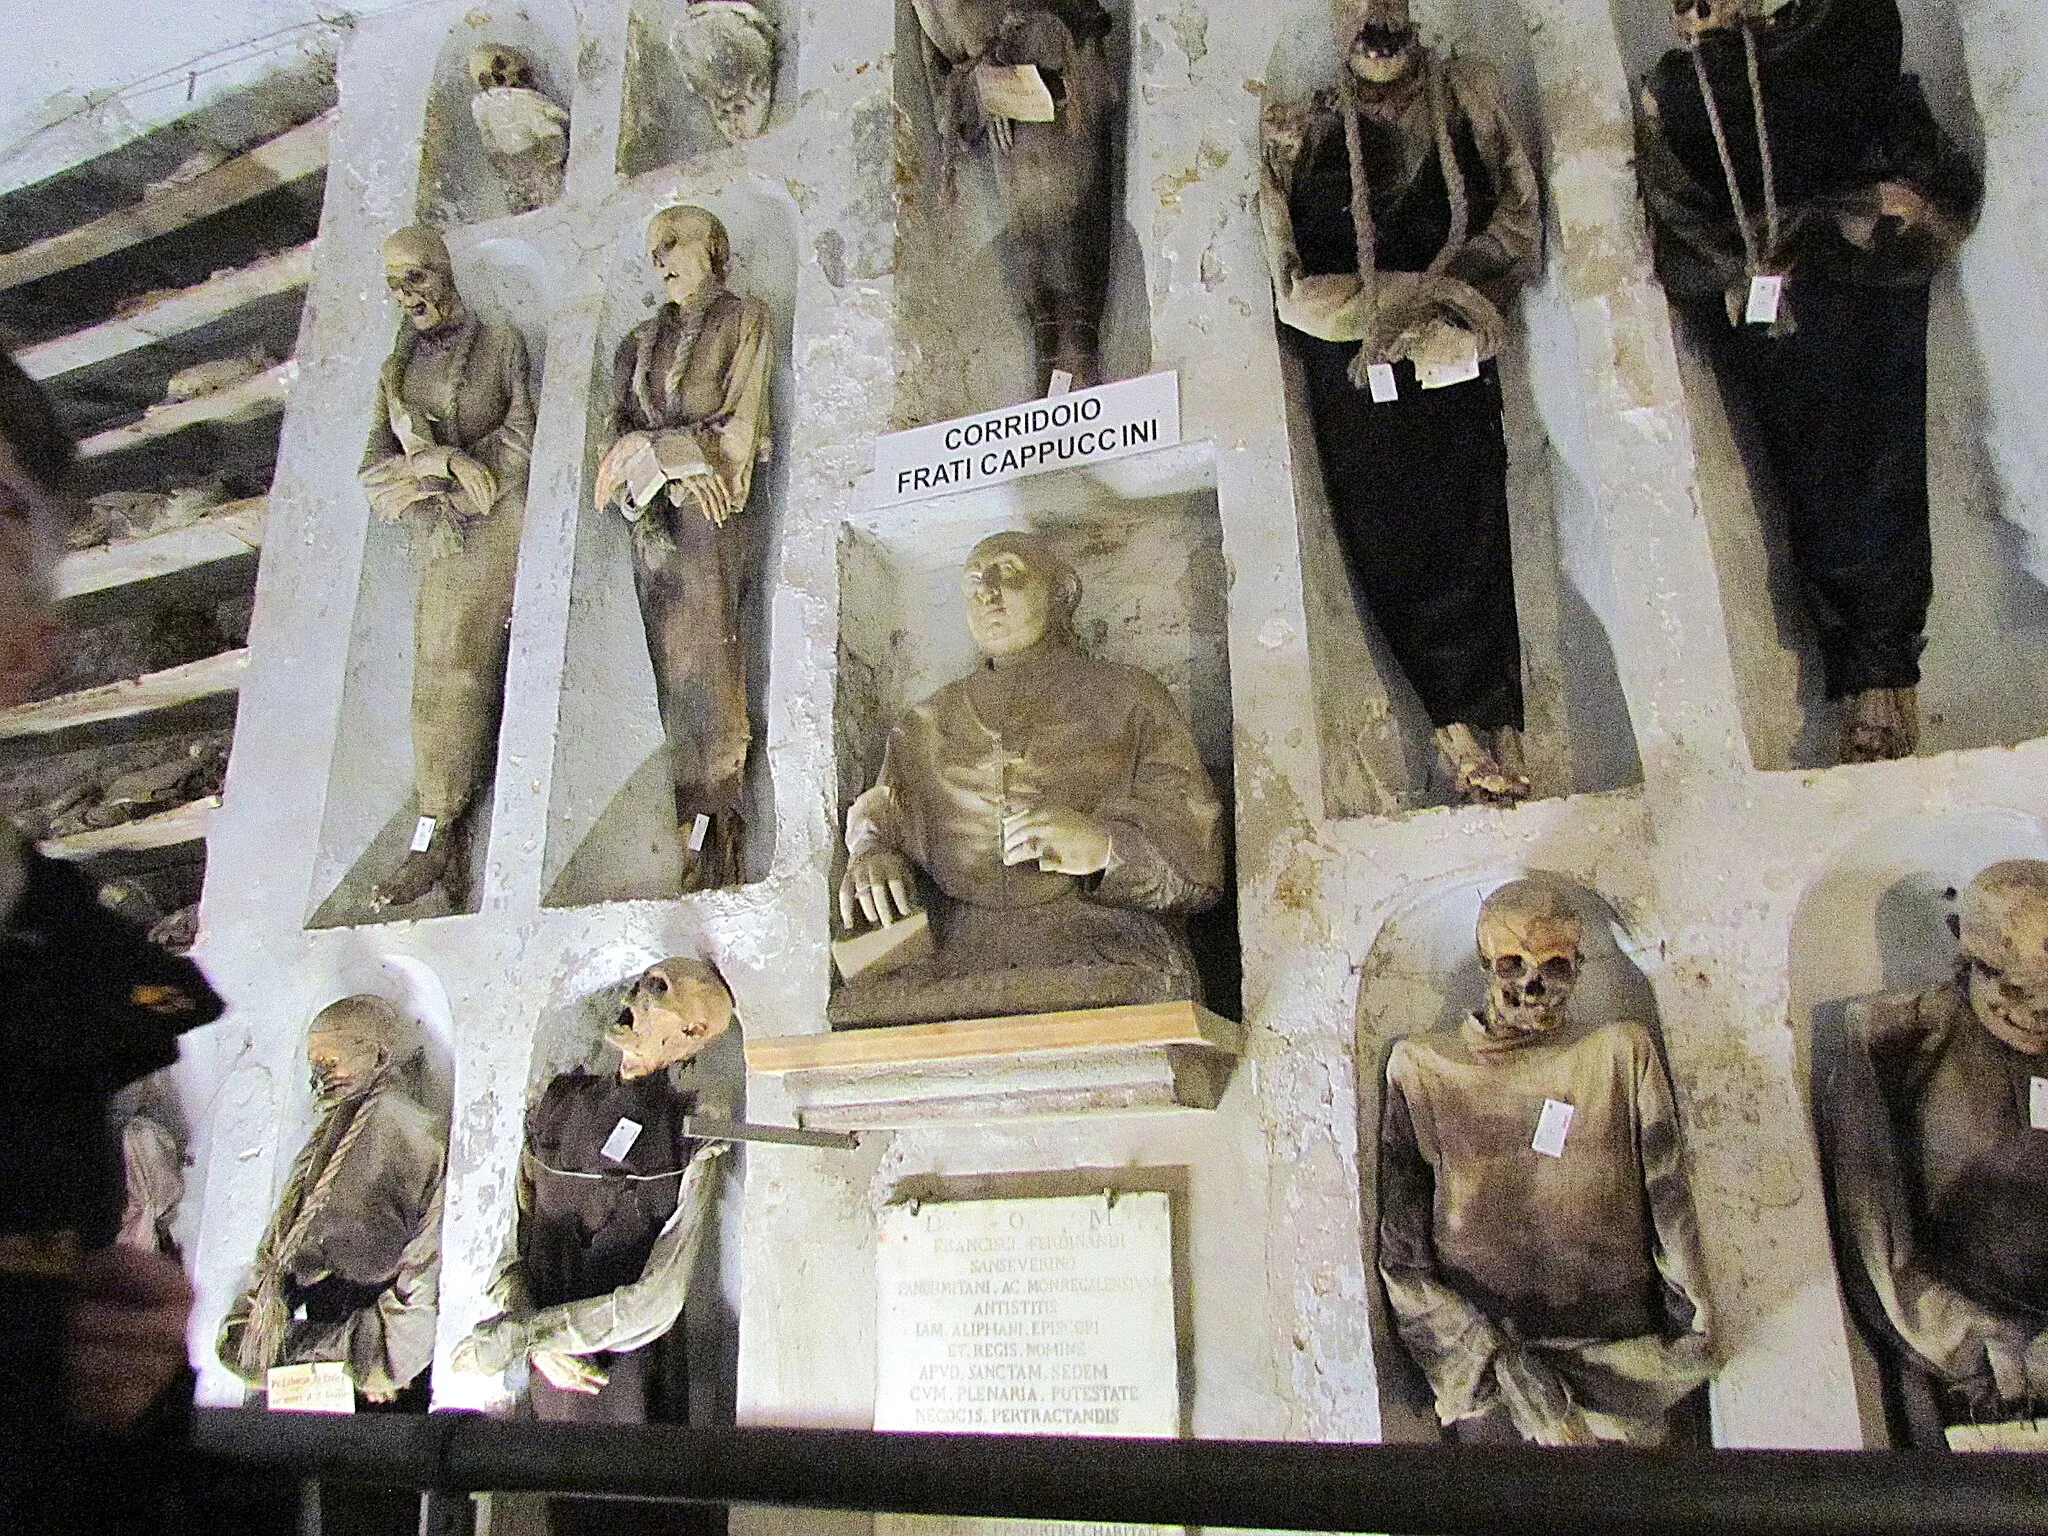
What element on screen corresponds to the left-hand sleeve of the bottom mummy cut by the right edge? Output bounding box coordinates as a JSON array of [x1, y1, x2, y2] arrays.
[[1825, 997, 2032, 1405]]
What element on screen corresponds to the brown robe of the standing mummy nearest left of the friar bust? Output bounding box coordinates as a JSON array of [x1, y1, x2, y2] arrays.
[[612, 291, 774, 819]]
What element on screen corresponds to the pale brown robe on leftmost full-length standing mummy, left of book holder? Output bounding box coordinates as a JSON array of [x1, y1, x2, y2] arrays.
[[360, 315, 535, 821]]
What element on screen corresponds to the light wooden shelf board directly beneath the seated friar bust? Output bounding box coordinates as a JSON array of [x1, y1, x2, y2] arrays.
[[748, 1004, 1245, 1073]]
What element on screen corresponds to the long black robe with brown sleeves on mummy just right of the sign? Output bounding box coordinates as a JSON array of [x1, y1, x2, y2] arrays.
[[1260, 57, 1540, 727]]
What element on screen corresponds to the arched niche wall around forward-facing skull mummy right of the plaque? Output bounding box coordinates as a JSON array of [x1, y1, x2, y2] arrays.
[[1354, 866, 1706, 1444]]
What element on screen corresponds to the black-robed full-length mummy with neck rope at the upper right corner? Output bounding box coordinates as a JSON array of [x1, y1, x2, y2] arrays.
[[1636, 0, 1980, 762]]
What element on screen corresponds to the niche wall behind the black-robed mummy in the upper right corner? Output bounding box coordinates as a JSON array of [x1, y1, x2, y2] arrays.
[[1612, 0, 2048, 770]]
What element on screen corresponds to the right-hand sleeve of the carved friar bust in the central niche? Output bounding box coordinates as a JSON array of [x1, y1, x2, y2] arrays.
[[1087, 676, 1223, 911]]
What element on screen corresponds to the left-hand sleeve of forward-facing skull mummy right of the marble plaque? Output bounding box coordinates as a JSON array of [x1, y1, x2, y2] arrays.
[[1378, 1040, 1503, 1423]]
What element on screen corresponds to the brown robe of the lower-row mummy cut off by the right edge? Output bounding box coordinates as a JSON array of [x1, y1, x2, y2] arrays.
[[1821, 985, 2048, 1413]]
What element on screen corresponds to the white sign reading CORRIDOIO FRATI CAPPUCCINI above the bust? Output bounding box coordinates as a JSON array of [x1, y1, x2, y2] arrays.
[[872, 373, 1180, 506]]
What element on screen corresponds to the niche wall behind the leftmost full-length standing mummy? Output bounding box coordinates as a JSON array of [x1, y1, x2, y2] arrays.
[[307, 231, 567, 928]]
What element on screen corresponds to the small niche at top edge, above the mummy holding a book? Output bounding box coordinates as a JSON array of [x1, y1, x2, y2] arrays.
[[618, 0, 801, 176]]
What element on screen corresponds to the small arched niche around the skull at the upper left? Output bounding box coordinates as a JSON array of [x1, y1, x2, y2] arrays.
[[420, 0, 578, 227]]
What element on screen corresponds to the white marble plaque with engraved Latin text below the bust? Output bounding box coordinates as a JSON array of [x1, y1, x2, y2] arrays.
[[874, 1192, 1180, 1436]]
